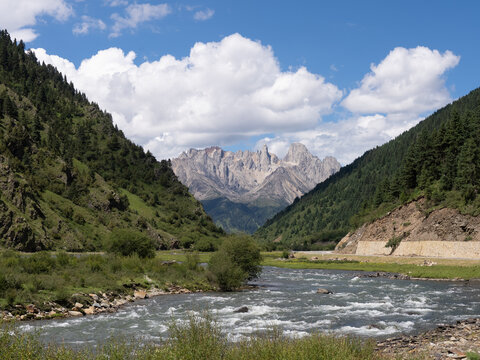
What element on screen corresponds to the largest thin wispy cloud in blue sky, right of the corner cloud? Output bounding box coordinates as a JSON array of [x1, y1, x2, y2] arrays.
[[110, 3, 172, 37]]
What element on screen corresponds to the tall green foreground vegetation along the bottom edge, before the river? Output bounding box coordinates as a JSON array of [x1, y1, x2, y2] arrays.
[[0, 315, 381, 360]]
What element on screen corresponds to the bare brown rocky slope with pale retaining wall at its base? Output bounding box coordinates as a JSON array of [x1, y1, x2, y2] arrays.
[[335, 198, 480, 258]]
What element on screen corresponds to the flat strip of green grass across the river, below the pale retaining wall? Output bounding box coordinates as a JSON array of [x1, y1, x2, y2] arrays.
[[262, 252, 480, 280]]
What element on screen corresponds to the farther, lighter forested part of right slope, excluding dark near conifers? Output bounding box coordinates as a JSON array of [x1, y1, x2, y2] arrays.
[[256, 89, 480, 248]]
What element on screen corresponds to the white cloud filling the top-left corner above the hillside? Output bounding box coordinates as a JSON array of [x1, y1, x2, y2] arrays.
[[0, 0, 73, 42]]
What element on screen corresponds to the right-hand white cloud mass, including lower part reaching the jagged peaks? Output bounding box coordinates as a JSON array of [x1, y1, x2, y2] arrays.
[[256, 46, 460, 165]]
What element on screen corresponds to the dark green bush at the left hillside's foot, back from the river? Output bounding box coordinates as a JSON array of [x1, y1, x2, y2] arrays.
[[107, 229, 156, 258]]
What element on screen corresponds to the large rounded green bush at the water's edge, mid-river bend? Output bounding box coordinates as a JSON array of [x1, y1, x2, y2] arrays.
[[209, 236, 262, 291]]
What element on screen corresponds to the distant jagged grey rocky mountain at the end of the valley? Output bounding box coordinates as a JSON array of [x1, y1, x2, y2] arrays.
[[172, 143, 340, 232]]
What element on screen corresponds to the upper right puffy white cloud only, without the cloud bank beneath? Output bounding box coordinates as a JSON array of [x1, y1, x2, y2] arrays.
[[342, 46, 460, 114]]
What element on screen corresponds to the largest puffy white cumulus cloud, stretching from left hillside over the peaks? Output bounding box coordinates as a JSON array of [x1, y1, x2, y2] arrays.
[[34, 34, 342, 158]]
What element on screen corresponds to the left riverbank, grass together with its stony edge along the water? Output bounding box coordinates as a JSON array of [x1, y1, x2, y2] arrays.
[[0, 251, 215, 320]]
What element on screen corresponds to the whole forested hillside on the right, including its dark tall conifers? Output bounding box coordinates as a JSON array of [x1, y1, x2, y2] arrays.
[[256, 89, 480, 249]]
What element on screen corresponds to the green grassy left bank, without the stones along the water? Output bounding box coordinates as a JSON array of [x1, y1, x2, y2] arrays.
[[0, 251, 212, 314]]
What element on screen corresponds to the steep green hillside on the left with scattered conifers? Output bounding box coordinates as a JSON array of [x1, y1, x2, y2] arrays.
[[0, 31, 223, 251]]
